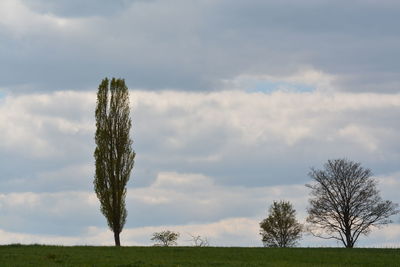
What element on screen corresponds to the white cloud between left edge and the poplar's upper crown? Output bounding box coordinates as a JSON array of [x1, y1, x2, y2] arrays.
[[0, 91, 95, 157]]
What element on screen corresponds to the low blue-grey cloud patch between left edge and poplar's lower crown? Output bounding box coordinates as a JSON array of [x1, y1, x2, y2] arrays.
[[0, 192, 104, 236]]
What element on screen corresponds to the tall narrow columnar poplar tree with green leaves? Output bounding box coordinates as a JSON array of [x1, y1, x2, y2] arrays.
[[93, 78, 135, 246]]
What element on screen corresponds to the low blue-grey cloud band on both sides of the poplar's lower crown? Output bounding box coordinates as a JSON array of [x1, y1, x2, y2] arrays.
[[0, 176, 306, 236]]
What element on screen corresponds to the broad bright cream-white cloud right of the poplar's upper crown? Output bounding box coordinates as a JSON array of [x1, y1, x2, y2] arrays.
[[134, 91, 400, 157]]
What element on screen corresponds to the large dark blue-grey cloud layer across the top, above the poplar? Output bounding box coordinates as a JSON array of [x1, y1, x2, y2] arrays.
[[0, 0, 400, 92]]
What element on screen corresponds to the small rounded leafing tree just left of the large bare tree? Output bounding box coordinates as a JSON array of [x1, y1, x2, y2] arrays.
[[260, 201, 302, 247]]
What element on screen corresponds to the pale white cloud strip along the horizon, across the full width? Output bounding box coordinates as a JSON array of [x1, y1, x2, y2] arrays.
[[0, 215, 400, 248]]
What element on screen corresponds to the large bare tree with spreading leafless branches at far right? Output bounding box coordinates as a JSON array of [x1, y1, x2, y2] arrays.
[[306, 159, 399, 248]]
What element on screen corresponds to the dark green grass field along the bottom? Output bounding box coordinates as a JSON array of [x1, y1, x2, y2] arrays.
[[0, 245, 400, 267]]
